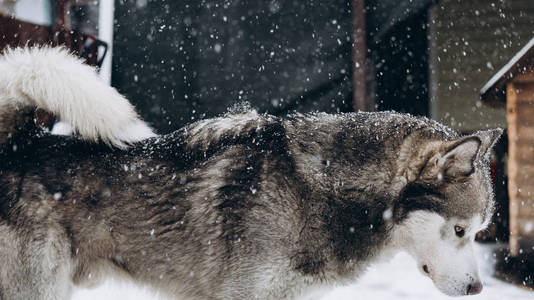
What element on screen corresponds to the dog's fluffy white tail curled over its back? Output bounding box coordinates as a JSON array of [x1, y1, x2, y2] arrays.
[[0, 47, 155, 148]]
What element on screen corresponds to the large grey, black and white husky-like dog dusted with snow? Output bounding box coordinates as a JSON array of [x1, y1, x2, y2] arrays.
[[0, 47, 502, 299]]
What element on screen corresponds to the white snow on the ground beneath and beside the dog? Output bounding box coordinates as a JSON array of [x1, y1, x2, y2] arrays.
[[72, 247, 534, 300]]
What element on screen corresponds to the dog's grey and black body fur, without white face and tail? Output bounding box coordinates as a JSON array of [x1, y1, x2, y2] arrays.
[[0, 106, 500, 299]]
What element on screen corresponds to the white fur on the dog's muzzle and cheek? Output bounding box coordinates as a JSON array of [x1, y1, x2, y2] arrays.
[[393, 211, 483, 296]]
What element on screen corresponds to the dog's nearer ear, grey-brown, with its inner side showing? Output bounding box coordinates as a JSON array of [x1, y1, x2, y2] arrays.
[[426, 135, 482, 182]]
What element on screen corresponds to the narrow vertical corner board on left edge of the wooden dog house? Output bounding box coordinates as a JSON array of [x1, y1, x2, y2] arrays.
[[506, 82, 519, 256]]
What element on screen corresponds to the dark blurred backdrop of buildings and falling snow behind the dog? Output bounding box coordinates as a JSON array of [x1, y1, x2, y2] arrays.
[[0, 0, 534, 297]]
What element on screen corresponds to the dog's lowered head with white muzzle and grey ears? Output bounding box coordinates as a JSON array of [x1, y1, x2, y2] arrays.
[[394, 129, 502, 296]]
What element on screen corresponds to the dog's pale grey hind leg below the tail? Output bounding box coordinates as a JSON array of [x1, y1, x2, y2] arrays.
[[0, 224, 72, 300]]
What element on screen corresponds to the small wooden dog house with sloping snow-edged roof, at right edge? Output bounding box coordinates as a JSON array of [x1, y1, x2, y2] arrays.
[[481, 38, 534, 256]]
